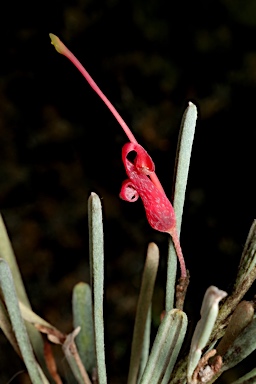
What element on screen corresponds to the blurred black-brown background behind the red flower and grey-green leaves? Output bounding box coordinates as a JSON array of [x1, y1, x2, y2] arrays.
[[0, 0, 256, 384]]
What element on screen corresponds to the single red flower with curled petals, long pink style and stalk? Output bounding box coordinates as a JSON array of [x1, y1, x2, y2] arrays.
[[50, 33, 187, 278]]
